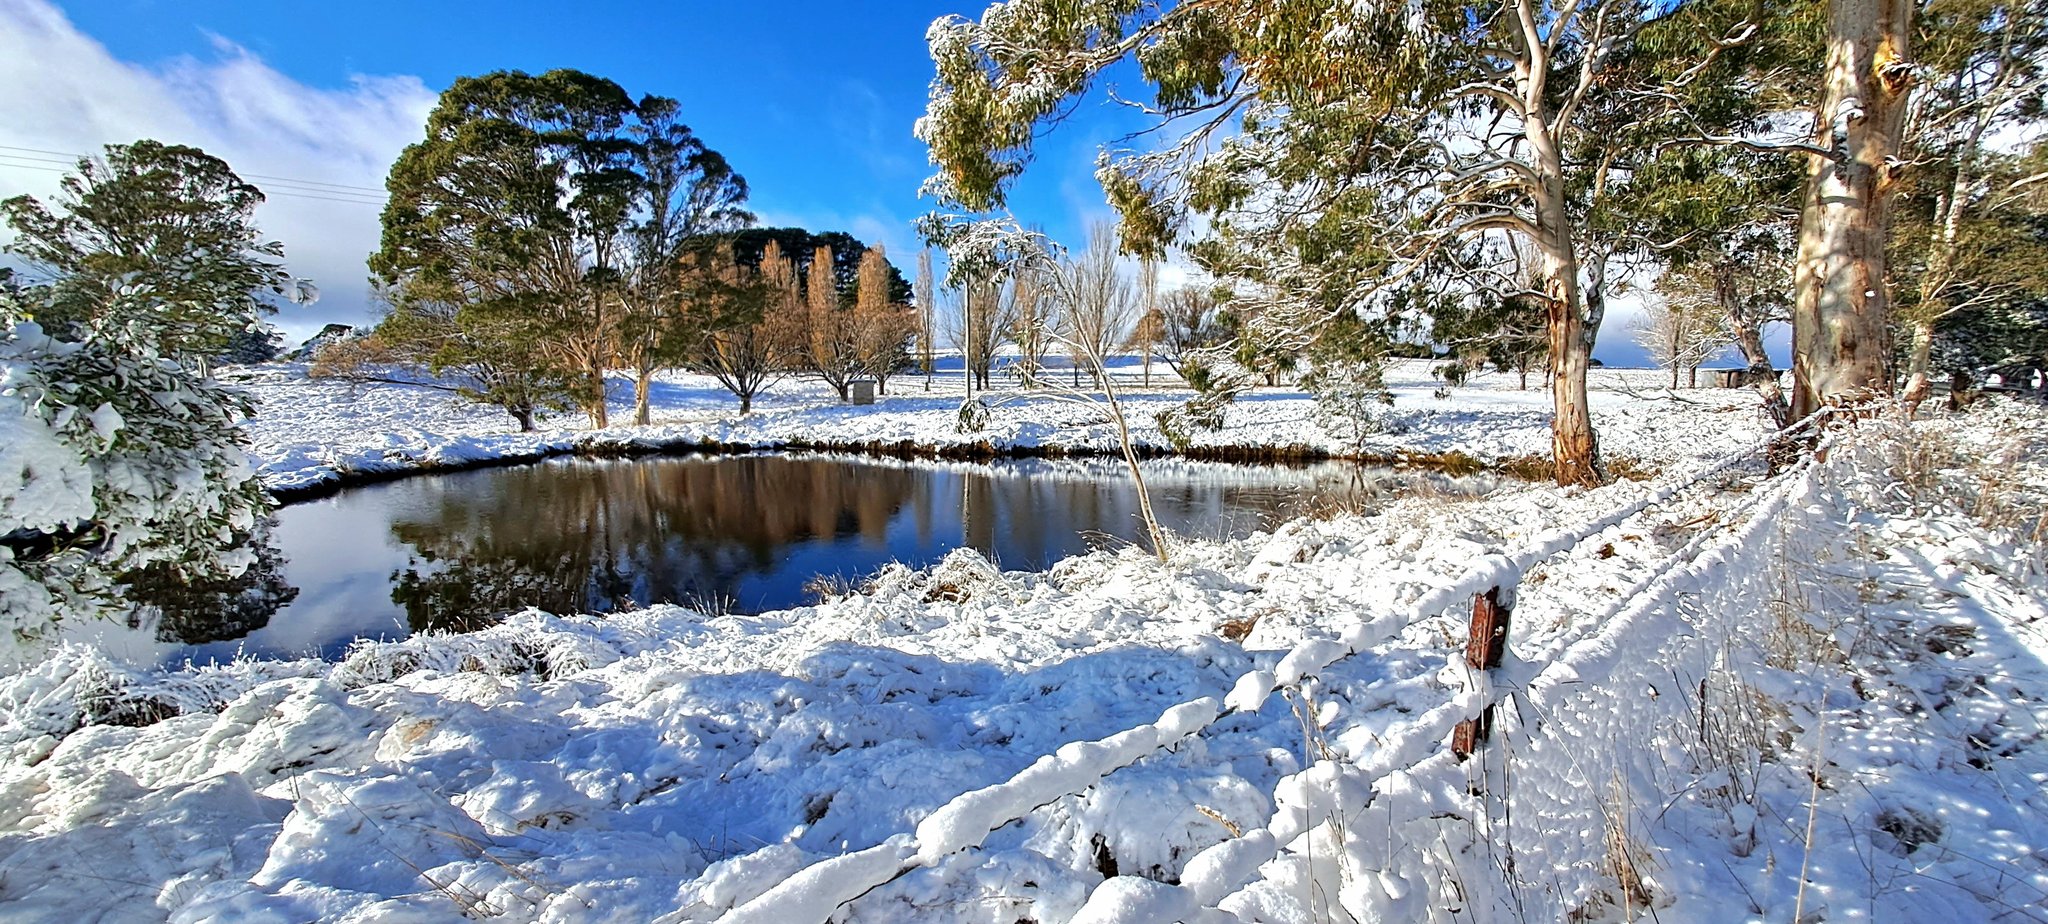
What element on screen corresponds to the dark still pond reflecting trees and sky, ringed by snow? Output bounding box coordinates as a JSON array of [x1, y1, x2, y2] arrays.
[[79, 453, 1491, 664]]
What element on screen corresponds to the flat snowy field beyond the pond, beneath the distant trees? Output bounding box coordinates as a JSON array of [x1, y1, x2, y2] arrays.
[[229, 359, 1763, 492]]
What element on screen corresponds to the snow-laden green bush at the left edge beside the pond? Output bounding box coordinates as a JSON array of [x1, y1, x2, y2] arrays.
[[0, 307, 268, 641]]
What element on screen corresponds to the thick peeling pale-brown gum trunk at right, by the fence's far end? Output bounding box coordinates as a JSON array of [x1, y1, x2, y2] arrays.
[[1792, 0, 1913, 418]]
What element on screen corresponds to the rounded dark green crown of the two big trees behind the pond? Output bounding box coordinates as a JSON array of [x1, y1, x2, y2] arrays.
[[371, 70, 752, 426]]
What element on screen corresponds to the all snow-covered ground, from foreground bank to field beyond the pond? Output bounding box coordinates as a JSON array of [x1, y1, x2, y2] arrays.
[[0, 373, 2048, 924]]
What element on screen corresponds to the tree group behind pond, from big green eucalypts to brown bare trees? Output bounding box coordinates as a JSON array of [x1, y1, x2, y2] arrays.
[[315, 70, 915, 430]]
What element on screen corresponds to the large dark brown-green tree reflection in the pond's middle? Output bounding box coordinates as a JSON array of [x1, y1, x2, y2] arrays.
[[391, 455, 920, 631]]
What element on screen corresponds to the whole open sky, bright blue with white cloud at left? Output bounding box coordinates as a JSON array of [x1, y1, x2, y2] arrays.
[[0, 0, 1744, 365]]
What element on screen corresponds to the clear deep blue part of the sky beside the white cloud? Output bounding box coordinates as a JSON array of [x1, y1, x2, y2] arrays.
[[61, 0, 1024, 247]]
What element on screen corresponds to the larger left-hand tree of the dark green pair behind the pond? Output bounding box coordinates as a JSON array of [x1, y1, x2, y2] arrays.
[[371, 70, 639, 426]]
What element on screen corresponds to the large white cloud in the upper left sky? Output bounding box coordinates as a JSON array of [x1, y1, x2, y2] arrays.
[[0, 0, 434, 348]]
